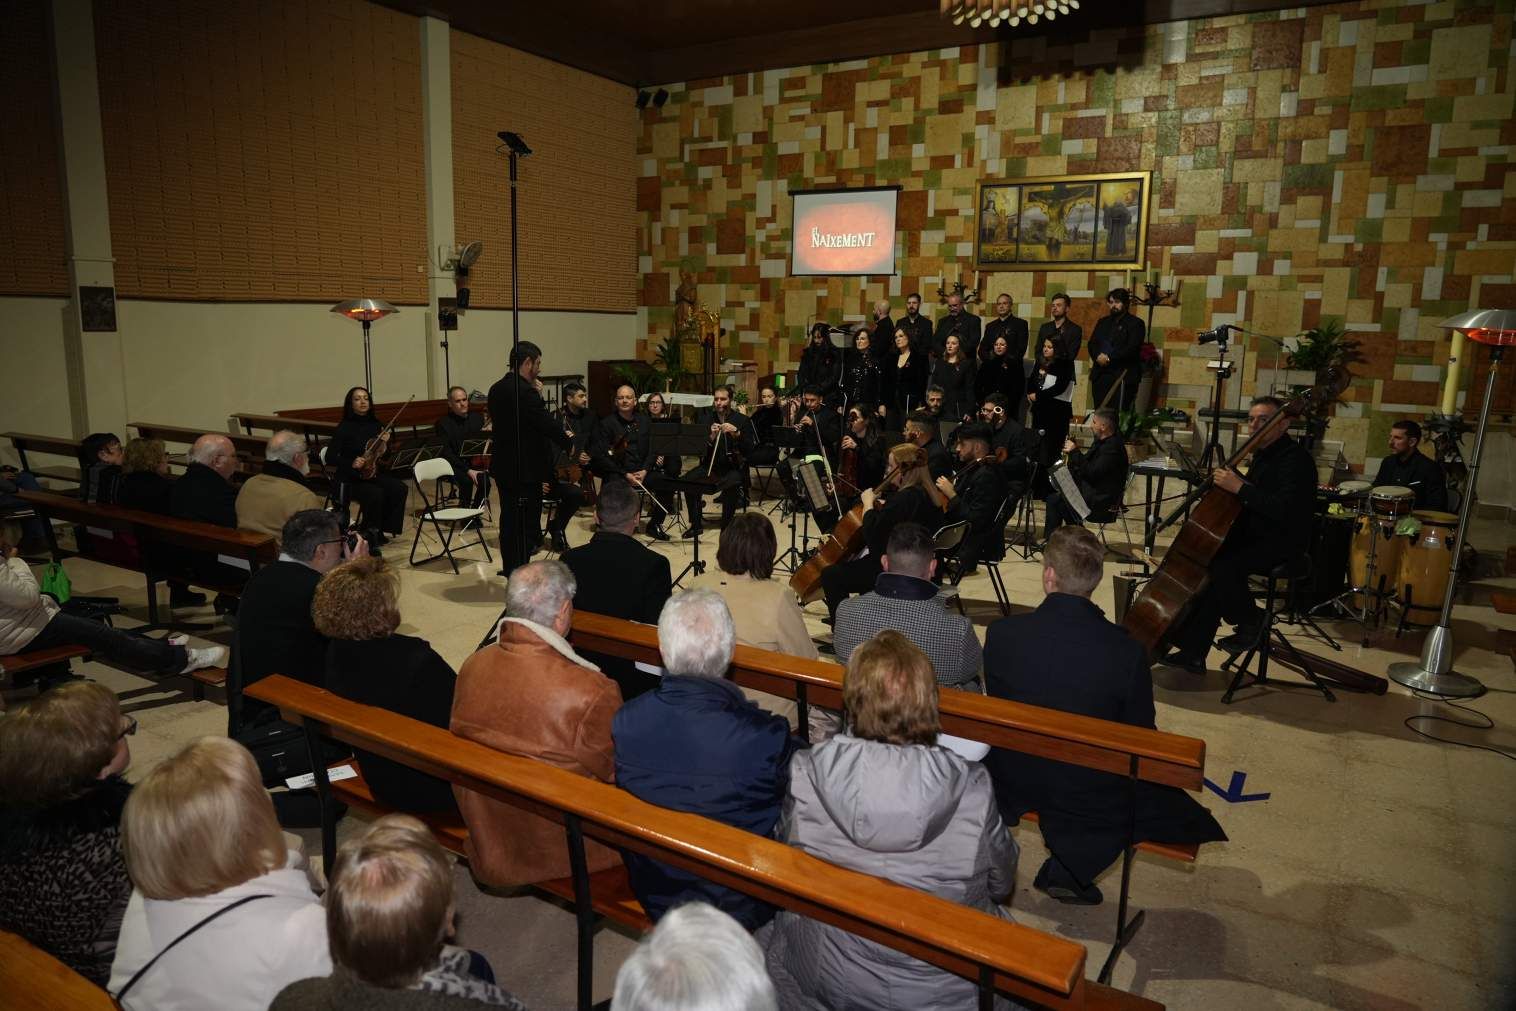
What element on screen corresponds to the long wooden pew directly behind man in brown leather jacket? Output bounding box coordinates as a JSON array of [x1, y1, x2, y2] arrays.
[[247, 675, 1158, 1008]]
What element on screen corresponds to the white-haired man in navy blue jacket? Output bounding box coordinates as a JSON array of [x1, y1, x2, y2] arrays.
[[609, 590, 800, 931]]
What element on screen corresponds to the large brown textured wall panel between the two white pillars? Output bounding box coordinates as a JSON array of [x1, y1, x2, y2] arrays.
[[96, 0, 426, 305]]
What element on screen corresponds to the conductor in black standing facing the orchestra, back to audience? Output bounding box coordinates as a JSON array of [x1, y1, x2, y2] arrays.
[[490, 341, 573, 576]]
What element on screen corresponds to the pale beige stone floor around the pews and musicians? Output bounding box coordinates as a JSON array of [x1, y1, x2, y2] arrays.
[[14, 491, 1516, 1009]]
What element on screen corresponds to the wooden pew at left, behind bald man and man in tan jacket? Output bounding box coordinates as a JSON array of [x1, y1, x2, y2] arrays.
[[18, 491, 279, 624]]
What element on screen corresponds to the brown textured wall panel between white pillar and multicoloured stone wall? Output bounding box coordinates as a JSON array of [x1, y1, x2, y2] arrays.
[[452, 32, 640, 312]]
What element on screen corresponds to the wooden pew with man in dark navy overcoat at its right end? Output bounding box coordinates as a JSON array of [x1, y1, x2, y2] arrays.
[[569, 611, 1205, 982]]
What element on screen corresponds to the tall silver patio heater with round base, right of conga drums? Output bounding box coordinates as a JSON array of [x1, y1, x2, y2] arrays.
[[1389, 309, 1516, 699]]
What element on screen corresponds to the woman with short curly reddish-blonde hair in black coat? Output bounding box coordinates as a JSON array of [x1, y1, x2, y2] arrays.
[[315, 558, 458, 812]]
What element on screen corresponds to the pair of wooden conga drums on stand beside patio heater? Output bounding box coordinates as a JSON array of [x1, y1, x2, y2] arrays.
[[1311, 480, 1458, 646]]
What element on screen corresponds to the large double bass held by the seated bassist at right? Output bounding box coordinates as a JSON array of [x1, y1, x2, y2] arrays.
[[1122, 368, 1349, 656]]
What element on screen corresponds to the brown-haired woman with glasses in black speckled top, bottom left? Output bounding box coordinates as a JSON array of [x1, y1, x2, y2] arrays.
[[0, 682, 136, 997]]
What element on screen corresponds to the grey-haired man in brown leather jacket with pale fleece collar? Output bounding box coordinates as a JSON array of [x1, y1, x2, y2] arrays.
[[452, 560, 622, 887]]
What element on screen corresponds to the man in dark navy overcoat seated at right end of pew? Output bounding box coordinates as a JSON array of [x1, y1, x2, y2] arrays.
[[984, 526, 1226, 905]]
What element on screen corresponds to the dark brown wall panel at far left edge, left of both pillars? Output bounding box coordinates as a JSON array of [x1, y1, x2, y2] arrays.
[[0, 3, 68, 296]]
